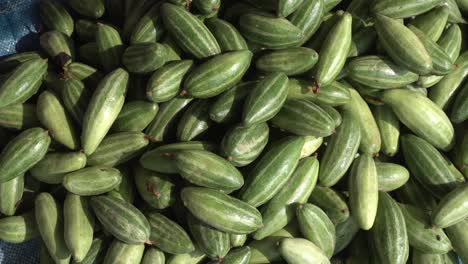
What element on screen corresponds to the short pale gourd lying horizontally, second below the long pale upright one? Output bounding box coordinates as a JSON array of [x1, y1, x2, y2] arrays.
[[63, 166, 122, 196]]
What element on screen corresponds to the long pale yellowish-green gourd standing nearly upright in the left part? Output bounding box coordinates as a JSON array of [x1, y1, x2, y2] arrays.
[[81, 68, 128, 155]]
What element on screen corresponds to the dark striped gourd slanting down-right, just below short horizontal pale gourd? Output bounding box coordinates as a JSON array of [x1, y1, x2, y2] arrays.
[[90, 195, 150, 244]]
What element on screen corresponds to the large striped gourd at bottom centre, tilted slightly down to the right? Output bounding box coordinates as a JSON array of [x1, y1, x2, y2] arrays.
[[181, 187, 262, 234]]
